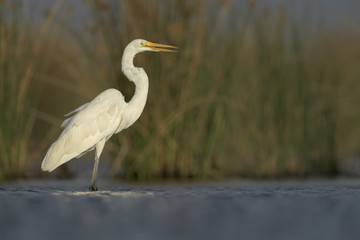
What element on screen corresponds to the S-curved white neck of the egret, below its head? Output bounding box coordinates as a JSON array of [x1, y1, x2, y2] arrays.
[[121, 47, 149, 127]]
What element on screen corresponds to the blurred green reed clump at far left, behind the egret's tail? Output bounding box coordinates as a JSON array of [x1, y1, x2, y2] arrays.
[[0, 1, 59, 180]]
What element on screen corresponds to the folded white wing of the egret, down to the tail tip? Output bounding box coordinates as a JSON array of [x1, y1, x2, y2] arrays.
[[41, 89, 126, 171]]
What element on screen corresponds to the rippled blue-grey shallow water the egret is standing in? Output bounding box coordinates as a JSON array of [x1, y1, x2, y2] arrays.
[[0, 180, 360, 240]]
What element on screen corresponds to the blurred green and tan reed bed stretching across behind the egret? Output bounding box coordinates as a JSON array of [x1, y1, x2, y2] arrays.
[[0, 0, 360, 180]]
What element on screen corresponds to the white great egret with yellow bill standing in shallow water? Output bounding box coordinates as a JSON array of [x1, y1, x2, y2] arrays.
[[41, 39, 177, 191]]
